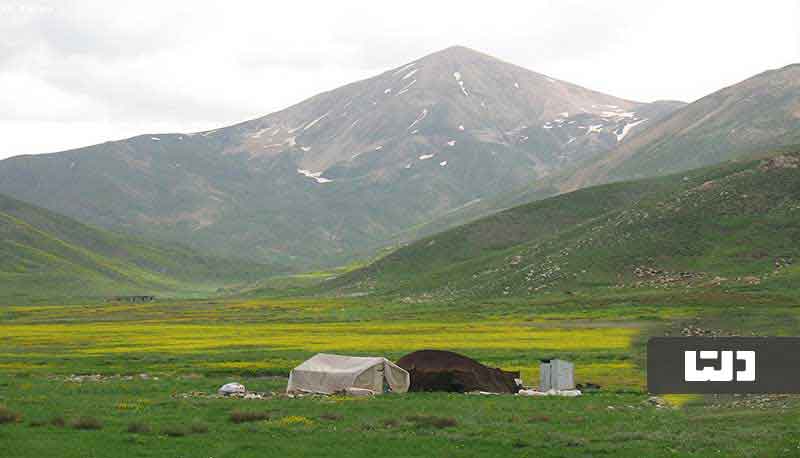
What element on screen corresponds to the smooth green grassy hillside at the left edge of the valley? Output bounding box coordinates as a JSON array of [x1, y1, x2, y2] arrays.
[[0, 195, 280, 300]]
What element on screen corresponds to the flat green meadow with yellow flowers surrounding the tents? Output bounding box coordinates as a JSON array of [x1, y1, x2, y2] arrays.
[[0, 288, 800, 457]]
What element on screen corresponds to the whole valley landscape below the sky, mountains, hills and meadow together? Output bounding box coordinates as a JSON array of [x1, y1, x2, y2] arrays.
[[0, 46, 800, 458]]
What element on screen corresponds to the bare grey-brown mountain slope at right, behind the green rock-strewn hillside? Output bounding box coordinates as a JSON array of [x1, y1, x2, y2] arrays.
[[398, 64, 800, 243]]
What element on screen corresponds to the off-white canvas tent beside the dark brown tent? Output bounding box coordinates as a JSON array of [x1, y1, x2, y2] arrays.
[[286, 353, 411, 394]]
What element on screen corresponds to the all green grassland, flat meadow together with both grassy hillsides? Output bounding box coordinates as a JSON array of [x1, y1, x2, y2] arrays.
[[0, 152, 800, 458]]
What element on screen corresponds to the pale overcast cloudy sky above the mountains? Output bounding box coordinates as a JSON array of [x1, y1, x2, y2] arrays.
[[0, 0, 800, 158]]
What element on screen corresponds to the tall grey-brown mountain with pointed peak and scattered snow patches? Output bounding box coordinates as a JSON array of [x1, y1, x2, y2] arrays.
[[0, 47, 681, 267]]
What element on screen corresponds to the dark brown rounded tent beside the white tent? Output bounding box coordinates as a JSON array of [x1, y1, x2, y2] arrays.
[[397, 350, 522, 393]]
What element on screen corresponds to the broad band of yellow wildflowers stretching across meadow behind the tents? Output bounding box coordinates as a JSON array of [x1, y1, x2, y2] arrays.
[[0, 322, 638, 355]]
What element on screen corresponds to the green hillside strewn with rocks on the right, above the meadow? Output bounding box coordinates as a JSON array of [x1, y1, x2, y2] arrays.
[[325, 153, 800, 298]]
